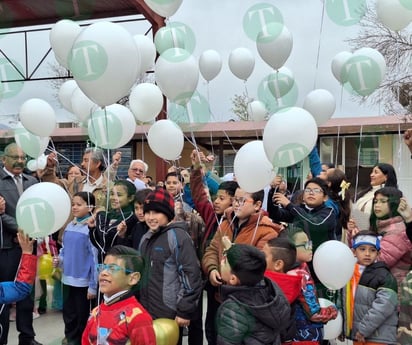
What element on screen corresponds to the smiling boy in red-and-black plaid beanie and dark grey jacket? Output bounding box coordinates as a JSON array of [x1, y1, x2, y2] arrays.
[[140, 187, 202, 344]]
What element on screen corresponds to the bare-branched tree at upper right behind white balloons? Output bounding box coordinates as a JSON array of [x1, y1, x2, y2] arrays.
[[347, 7, 412, 121]]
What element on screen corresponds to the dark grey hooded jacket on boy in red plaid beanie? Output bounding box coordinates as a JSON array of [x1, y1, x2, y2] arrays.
[[139, 222, 202, 319]]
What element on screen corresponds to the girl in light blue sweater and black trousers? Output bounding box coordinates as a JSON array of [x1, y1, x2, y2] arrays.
[[53, 192, 97, 345]]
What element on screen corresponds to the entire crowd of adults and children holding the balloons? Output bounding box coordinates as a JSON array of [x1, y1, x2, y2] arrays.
[[0, 129, 412, 345]]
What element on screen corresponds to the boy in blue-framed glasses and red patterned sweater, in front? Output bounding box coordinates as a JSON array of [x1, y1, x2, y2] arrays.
[[82, 245, 156, 345]]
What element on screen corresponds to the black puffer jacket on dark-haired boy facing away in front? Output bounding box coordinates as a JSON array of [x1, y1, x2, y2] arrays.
[[216, 278, 291, 345]]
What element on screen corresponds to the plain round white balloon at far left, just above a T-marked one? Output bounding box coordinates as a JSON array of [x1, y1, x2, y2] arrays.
[[19, 98, 56, 137]]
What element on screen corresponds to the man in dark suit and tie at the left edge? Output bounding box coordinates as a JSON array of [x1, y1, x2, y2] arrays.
[[0, 143, 41, 345]]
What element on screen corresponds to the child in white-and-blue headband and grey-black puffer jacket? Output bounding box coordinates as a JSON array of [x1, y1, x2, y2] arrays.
[[345, 231, 398, 345]]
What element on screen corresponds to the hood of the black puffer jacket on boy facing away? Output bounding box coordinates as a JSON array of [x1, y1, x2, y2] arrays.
[[221, 278, 290, 332]]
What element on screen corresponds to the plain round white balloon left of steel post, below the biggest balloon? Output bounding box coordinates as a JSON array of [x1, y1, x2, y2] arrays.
[[129, 83, 163, 122]]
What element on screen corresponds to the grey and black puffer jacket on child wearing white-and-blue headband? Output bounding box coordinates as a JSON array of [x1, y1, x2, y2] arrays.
[[351, 262, 398, 344]]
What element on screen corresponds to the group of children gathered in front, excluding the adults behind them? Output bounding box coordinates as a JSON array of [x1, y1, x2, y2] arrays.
[[25, 144, 412, 345]]
